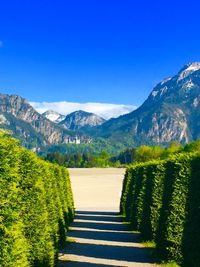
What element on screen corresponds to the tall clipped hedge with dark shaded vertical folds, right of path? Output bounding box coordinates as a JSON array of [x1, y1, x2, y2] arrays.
[[120, 153, 200, 267]]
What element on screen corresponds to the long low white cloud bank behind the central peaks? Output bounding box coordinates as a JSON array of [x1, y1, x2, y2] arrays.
[[30, 101, 136, 119]]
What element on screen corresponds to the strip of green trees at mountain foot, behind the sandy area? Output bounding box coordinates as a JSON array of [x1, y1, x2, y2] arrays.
[[43, 141, 200, 168]]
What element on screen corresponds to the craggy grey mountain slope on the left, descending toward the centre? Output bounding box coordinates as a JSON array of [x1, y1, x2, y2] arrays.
[[0, 94, 87, 147]]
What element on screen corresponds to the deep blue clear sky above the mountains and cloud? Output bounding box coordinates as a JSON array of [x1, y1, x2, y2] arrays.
[[0, 0, 200, 105]]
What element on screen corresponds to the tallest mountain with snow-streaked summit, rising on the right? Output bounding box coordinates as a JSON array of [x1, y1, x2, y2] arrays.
[[94, 62, 200, 145]]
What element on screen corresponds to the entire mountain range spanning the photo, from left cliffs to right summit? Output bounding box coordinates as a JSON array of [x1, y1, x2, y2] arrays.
[[0, 62, 200, 152]]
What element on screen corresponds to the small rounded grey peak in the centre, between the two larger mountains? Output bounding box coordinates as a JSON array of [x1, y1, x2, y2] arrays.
[[59, 110, 105, 131]]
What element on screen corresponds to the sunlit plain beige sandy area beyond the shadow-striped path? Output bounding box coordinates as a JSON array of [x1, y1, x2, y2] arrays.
[[69, 168, 125, 212]]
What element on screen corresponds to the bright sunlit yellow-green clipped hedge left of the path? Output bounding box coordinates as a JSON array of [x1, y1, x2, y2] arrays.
[[0, 133, 74, 267]]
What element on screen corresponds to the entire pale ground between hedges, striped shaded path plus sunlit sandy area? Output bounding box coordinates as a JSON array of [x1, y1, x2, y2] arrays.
[[58, 169, 158, 267]]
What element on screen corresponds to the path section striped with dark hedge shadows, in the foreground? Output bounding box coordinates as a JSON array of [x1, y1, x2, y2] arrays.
[[58, 211, 155, 267]]
